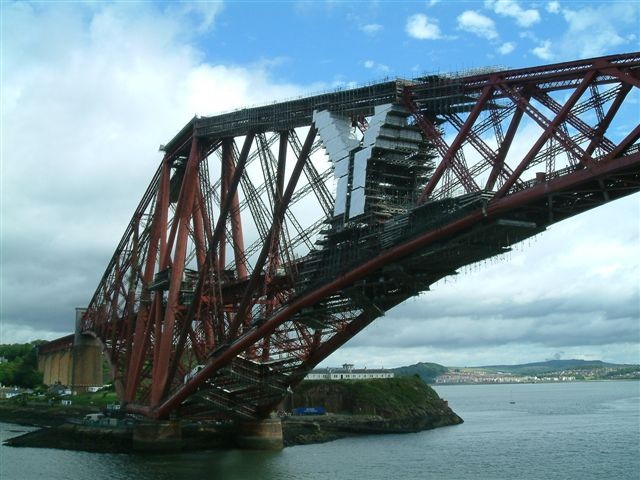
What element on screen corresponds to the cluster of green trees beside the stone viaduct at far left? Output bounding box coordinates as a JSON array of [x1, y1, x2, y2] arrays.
[[0, 340, 46, 388]]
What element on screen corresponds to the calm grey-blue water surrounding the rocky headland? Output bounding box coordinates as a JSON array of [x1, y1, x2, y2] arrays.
[[0, 381, 640, 480]]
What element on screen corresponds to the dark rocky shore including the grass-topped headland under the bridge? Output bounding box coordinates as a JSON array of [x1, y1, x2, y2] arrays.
[[0, 378, 463, 453]]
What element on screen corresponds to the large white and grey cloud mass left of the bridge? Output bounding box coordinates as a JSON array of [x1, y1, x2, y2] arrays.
[[0, 3, 302, 342]]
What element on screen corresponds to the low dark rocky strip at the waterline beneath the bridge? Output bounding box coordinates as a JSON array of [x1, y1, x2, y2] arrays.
[[0, 405, 463, 453]]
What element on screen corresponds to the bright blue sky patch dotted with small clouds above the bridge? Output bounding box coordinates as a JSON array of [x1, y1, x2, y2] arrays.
[[192, 0, 638, 85]]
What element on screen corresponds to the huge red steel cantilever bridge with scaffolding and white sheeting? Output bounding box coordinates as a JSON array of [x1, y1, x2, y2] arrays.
[[76, 53, 640, 419]]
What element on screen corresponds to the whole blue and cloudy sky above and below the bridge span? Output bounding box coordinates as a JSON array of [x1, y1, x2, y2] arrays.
[[0, 0, 640, 368]]
